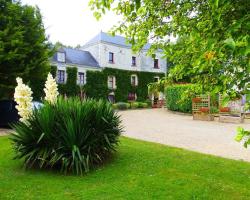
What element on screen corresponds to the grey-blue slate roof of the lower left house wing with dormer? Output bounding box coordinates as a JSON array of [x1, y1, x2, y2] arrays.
[[52, 47, 100, 67]]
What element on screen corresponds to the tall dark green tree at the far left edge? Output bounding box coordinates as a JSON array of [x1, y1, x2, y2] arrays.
[[0, 0, 52, 99]]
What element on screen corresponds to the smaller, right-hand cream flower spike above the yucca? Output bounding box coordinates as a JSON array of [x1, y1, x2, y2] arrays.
[[44, 73, 59, 104]]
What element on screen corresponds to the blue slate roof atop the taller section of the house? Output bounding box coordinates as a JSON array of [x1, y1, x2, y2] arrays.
[[85, 31, 151, 50]]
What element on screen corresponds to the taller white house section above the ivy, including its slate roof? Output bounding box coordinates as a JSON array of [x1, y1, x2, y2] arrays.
[[81, 32, 167, 73]]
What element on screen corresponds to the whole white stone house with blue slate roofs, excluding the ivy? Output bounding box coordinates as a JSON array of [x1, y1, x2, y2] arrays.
[[51, 32, 167, 89]]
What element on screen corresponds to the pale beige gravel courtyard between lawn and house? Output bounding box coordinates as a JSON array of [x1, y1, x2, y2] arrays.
[[120, 109, 250, 162]]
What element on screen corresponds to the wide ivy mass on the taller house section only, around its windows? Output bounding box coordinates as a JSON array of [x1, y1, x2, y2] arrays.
[[85, 68, 165, 102]]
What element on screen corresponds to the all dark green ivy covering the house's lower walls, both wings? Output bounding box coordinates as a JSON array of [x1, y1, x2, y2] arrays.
[[51, 66, 164, 102]]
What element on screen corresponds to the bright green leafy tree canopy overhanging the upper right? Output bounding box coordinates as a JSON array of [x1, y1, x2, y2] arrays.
[[89, 0, 250, 97]]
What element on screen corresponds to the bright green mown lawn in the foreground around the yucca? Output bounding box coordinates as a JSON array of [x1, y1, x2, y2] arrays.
[[0, 137, 250, 200]]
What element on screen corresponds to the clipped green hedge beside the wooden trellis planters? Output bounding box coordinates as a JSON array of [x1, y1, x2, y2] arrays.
[[165, 84, 192, 113]]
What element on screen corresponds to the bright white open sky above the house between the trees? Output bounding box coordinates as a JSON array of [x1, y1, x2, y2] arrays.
[[22, 0, 121, 46]]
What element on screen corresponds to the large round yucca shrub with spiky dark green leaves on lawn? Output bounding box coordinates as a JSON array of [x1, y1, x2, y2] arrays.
[[11, 98, 122, 174]]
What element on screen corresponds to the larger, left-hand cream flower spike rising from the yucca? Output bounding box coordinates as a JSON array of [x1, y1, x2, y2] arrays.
[[14, 77, 33, 122]]
